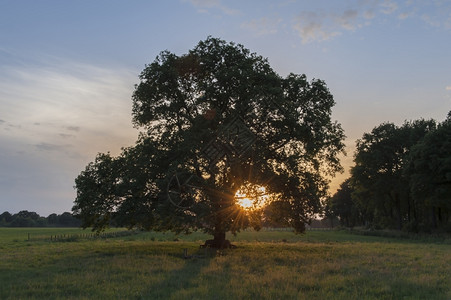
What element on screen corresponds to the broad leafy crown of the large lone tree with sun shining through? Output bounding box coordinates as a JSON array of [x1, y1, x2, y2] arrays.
[[73, 37, 344, 245]]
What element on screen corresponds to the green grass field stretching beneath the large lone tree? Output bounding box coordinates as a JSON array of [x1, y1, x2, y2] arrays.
[[0, 228, 451, 299]]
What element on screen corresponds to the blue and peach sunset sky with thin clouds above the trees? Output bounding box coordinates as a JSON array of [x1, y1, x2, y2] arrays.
[[0, 0, 451, 216]]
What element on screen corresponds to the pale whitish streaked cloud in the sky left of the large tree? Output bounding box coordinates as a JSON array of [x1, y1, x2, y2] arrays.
[[0, 59, 137, 161]]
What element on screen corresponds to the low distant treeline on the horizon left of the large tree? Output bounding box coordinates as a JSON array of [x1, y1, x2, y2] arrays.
[[0, 210, 81, 227]]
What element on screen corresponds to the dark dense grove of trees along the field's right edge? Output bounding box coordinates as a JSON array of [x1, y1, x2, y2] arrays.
[[326, 112, 451, 232]]
